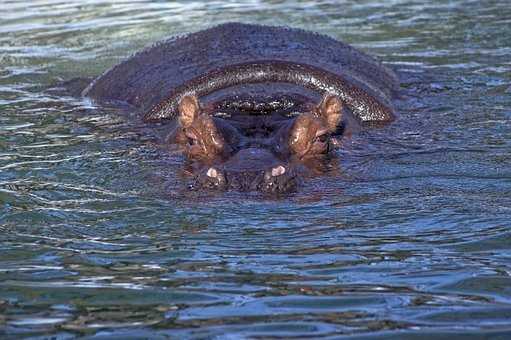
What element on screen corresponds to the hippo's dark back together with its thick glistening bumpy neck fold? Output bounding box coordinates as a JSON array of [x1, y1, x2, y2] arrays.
[[83, 23, 399, 121]]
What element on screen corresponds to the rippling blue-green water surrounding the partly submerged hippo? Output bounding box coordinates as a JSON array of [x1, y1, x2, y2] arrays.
[[0, 0, 511, 339]]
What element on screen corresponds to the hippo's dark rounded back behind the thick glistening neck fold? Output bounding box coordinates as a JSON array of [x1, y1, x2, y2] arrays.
[[83, 23, 399, 119]]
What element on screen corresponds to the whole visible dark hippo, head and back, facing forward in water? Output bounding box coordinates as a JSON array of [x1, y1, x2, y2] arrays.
[[82, 23, 399, 194]]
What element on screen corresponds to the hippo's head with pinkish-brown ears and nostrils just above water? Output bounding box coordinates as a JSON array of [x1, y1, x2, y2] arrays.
[[170, 94, 342, 194]]
